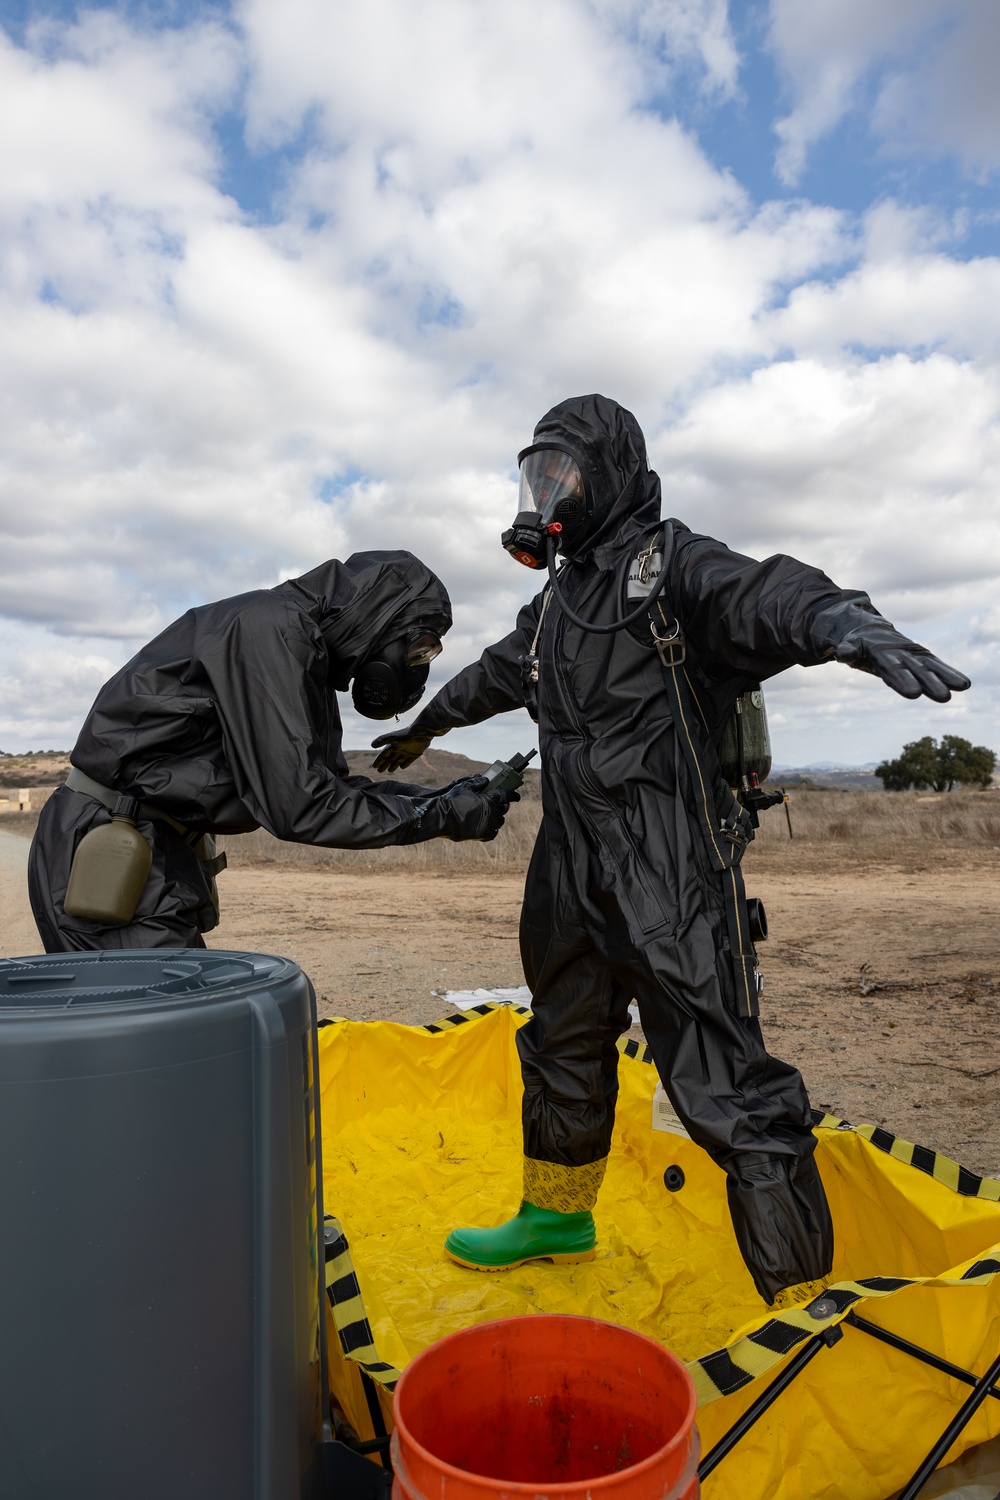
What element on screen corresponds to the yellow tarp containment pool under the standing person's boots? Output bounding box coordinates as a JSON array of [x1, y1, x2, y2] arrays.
[[319, 1008, 1000, 1500]]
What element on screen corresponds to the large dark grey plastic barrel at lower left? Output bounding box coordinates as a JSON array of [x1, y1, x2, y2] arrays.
[[0, 950, 324, 1500]]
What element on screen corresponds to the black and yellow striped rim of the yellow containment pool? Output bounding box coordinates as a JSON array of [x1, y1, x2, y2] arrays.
[[319, 1001, 1000, 1406]]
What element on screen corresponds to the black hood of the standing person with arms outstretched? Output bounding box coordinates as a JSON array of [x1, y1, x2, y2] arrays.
[[532, 396, 660, 558]]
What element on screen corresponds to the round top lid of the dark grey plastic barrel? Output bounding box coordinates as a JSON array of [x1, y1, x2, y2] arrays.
[[0, 948, 298, 1019]]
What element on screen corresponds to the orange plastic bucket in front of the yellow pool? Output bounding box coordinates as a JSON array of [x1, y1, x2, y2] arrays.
[[393, 1314, 700, 1500]]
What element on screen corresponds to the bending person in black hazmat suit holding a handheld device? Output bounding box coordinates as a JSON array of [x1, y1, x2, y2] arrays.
[[28, 552, 510, 953]]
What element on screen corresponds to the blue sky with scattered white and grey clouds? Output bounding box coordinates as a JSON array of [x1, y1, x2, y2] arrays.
[[0, 0, 1000, 765]]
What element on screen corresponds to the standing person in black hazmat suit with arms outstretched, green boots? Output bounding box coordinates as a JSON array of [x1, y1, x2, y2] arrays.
[[375, 396, 969, 1305]]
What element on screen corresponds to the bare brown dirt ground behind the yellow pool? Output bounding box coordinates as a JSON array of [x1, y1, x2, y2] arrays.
[[0, 831, 1000, 1176]]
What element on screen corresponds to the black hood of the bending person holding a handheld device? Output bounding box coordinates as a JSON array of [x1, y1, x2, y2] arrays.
[[280, 552, 451, 693]]
